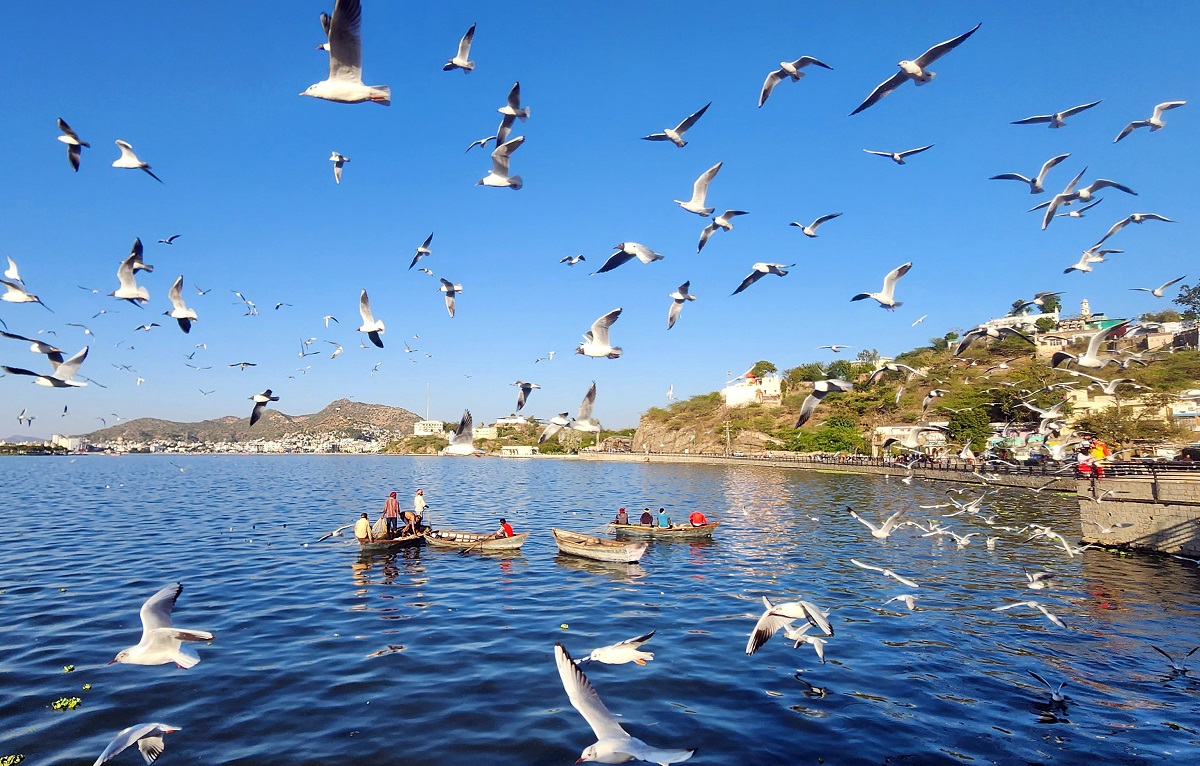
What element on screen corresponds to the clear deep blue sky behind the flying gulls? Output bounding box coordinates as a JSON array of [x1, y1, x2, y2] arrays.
[[0, 0, 1200, 435]]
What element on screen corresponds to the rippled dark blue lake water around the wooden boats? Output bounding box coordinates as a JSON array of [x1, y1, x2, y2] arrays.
[[0, 456, 1200, 766]]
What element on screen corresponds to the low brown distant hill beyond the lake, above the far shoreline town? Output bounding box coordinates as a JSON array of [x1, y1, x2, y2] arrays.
[[86, 399, 420, 443]]
